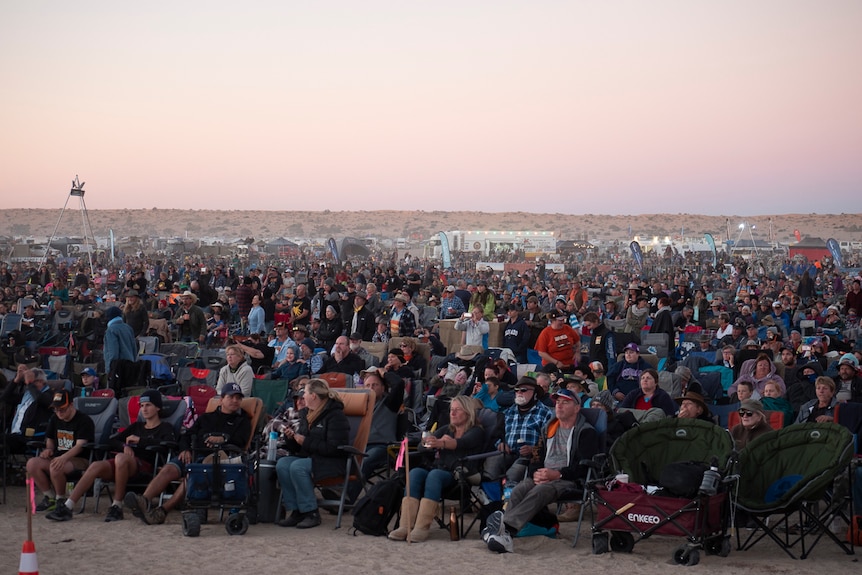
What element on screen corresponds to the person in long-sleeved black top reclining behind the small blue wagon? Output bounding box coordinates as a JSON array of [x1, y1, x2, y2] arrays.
[[124, 383, 251, 525]]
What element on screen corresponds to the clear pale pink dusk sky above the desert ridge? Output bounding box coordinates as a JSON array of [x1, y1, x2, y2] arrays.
[[0, 0, 862, 215]]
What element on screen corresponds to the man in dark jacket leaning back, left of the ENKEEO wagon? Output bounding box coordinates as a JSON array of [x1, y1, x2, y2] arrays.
[[482, 389, 599, 553]]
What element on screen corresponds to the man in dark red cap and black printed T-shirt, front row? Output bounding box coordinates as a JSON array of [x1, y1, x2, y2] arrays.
[[27, 389, 96, 511]]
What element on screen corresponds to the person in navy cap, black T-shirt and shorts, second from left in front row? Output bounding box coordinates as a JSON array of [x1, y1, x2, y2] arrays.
[[46, 389, 176, 522]]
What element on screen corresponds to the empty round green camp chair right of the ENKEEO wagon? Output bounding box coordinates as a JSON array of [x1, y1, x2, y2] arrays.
[[737, 423, 853, 559]]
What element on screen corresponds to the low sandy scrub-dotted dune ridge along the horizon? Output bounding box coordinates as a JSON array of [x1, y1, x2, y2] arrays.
[[0, 209, 862, 243]]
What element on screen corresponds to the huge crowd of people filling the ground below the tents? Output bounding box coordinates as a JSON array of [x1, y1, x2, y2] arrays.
[[0, 243, 862, 551]]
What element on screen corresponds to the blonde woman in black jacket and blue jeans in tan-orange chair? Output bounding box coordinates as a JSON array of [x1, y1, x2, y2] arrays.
[[275, 379, 350, 529]]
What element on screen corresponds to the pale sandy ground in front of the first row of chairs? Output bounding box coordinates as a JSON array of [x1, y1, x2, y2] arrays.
[[0, 487, 859, 575]]
